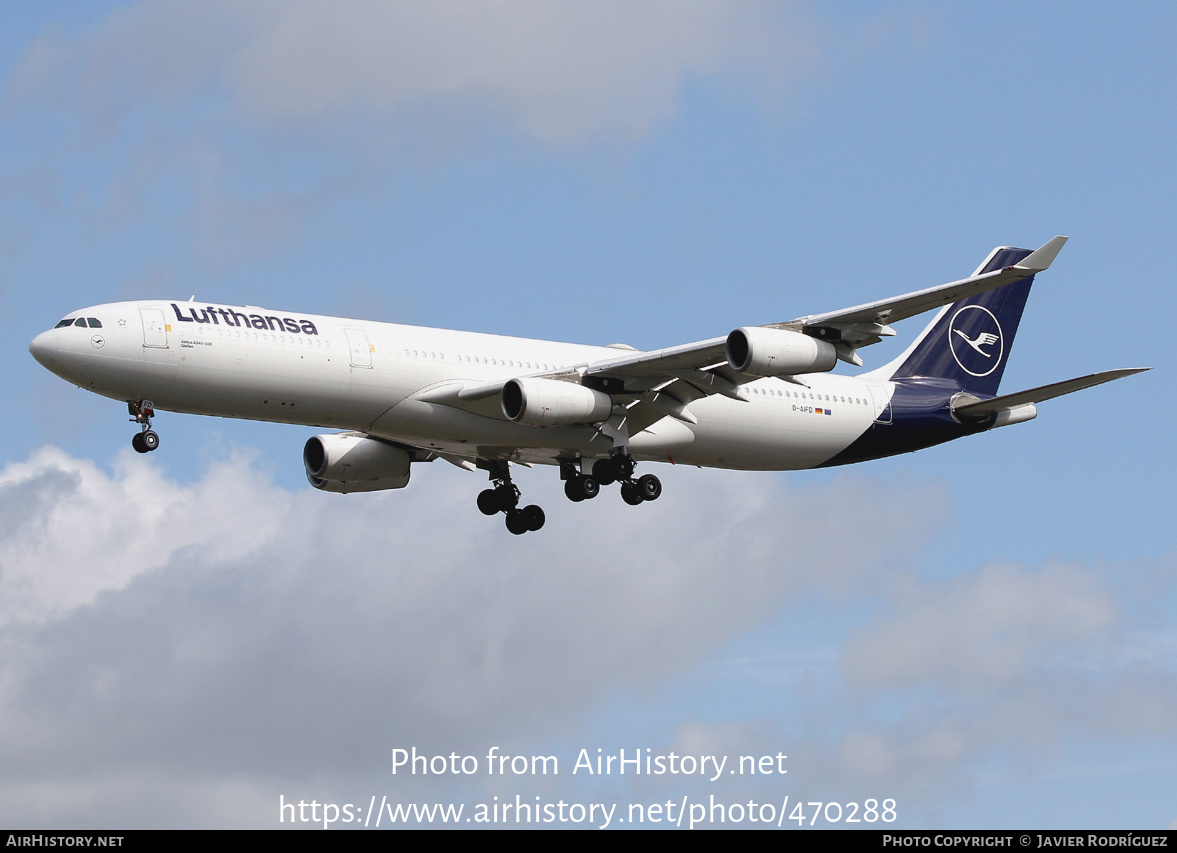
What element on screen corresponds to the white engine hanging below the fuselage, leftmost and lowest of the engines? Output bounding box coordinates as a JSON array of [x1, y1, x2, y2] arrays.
[[302, 433, 412, 494]]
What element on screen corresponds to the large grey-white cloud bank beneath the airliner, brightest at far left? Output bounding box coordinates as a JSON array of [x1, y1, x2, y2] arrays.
[[0, 448, 940, 825]]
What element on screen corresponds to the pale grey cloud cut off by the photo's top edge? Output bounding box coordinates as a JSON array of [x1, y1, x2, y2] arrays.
[[227, 0, 813, 142]]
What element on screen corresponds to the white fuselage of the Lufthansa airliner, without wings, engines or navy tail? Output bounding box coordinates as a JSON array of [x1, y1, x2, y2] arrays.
[[31, 301, 891, 469]]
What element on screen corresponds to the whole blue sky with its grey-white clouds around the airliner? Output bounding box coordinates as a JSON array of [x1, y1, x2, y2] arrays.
[[0, 1, 1177, 828]]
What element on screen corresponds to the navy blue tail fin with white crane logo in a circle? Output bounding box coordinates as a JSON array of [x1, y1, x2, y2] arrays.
[[891, 247, 1033, 395]]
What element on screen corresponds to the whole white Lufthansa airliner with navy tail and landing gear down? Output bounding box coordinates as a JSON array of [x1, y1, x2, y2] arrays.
[[29, 236, 1149, 534]]
